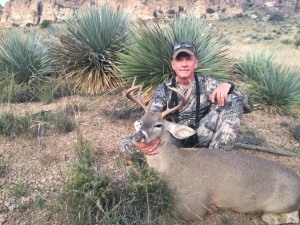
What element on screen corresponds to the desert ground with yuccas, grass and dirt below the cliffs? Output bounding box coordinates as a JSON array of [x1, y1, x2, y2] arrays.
[[0, 3, 300, 224]]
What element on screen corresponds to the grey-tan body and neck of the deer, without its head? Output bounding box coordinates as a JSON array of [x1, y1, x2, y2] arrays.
[[138, 118, 300, 221]]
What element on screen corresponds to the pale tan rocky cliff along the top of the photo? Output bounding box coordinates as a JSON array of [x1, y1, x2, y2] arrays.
[[0, 0, 300, 27]]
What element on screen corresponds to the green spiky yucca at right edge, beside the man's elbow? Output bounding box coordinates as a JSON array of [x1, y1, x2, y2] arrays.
[[246, 60, 300, 114]]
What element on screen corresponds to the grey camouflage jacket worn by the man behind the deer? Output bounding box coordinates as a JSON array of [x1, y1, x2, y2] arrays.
[[150, 74, 253, 125]]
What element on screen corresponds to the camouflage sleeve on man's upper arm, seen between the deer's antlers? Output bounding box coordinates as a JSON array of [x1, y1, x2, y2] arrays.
[[150, 83, 169, 112]]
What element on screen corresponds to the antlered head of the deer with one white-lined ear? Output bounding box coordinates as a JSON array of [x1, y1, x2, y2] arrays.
[[126, 79, 196, 143]]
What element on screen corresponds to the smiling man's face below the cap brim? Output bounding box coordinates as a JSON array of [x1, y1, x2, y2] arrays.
[[172, 53, 198, 79]]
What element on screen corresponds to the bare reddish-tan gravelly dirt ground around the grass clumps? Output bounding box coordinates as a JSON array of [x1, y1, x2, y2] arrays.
[[0, 89, 300, 225]]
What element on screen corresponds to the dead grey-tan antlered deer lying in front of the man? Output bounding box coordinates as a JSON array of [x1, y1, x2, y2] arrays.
[[126, 80, 300, 224]]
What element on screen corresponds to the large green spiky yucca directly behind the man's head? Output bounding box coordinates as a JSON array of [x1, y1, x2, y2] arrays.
[[120, 16, 228, 92]]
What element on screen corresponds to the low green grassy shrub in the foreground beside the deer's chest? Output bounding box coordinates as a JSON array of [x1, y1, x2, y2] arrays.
[[58, 140, 177, 225]]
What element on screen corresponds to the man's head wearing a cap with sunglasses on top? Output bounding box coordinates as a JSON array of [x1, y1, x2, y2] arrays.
[[172, 42, 198, 84]]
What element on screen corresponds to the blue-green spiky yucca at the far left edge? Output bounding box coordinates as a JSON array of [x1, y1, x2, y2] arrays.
[[0, 31, 53, 83]]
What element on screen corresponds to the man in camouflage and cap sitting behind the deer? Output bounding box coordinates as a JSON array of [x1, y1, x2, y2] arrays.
[[121, 42, 253, 151]]
